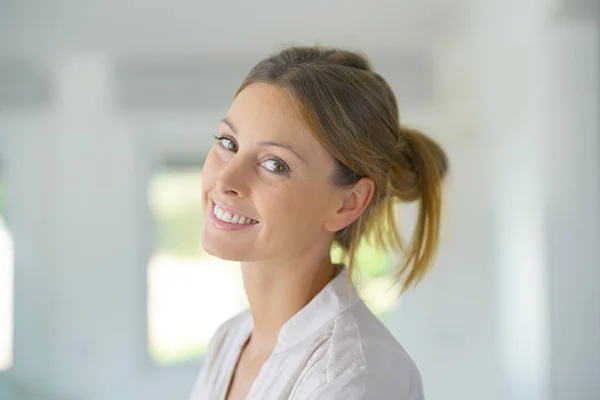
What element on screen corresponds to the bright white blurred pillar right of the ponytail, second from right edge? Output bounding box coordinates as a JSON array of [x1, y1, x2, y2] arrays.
[[476, 0, 551, 400]]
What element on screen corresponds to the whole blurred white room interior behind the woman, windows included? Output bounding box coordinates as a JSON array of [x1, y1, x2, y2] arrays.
[[0, 0, 600, 400]]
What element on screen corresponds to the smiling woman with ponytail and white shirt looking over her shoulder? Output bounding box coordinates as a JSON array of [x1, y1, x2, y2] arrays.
[[191, 47, 447, 400]]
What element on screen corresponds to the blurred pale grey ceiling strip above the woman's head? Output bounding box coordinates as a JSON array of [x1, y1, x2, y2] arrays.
[[0, 0, 469, 56]]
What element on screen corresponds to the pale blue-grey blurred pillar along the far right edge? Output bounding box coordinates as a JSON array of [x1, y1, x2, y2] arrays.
[[540, 15, 600, 400]]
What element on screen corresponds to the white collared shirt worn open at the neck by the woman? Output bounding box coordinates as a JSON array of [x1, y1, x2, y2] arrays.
[[190, 268, 424, 400]]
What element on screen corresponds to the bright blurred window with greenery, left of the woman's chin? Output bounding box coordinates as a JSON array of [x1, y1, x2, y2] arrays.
[[147, 166, 247, 365]]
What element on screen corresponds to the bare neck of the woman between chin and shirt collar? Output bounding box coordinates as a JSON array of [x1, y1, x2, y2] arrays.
[[241, 253, 336, 352]]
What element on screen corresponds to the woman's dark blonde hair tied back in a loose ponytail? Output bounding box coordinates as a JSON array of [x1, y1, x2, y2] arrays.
[[238, 47, 448, 291]]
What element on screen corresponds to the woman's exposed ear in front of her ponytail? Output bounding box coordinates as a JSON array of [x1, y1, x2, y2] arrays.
[[325, 178, 375, 232]]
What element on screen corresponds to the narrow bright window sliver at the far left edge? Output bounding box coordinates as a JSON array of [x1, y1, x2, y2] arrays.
[[0, 176, 13, 371]]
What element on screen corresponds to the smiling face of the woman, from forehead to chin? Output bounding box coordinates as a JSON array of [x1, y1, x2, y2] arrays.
[[202, 83, 344, 261]]
